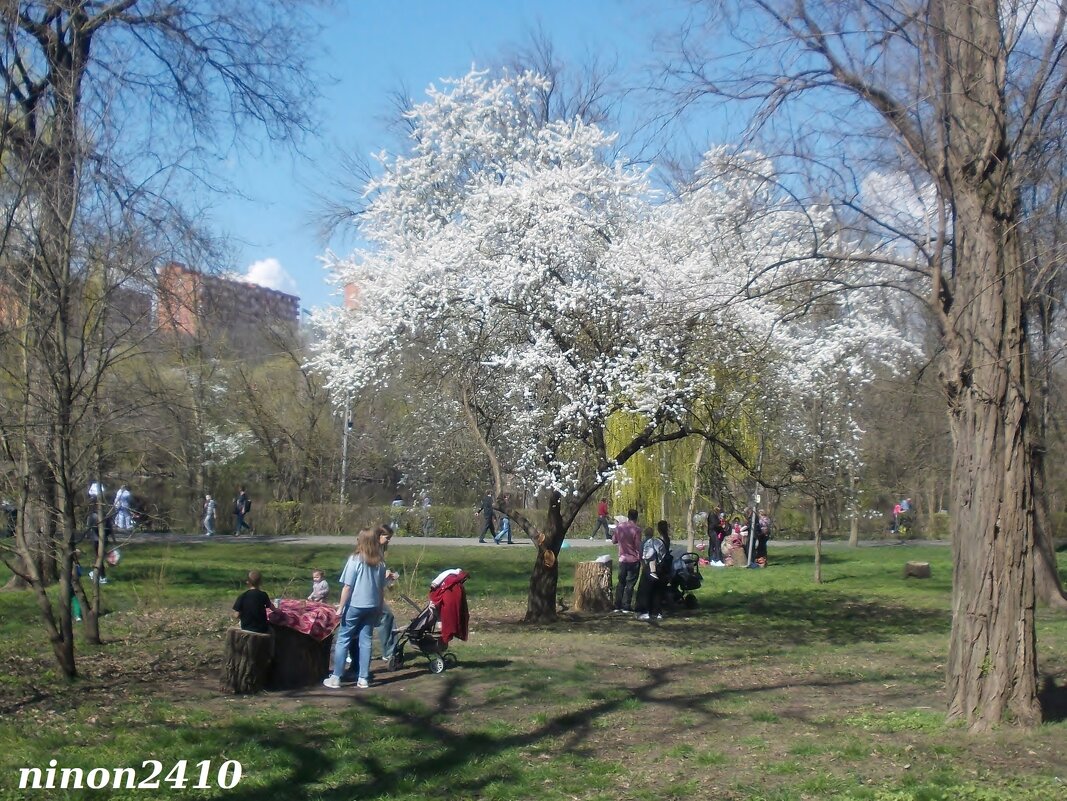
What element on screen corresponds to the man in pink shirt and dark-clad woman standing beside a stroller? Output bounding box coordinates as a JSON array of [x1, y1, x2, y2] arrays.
[[611, 509, 674, 621]]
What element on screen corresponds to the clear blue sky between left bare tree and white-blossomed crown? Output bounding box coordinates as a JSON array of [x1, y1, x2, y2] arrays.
[[211, 0, 682, 309]]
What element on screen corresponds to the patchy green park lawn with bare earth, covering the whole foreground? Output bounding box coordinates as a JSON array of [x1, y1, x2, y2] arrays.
[[0, 540, 1067, 801]]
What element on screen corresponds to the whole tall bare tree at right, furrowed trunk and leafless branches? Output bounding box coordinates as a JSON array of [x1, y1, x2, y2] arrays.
[[671, 0, 1067, 731]]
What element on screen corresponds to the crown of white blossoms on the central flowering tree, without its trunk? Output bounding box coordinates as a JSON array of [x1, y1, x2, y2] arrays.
[[315, 71, 917, 495]]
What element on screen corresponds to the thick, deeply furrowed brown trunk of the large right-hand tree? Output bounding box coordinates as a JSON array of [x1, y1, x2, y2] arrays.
[[935, 0, 1040, 731]]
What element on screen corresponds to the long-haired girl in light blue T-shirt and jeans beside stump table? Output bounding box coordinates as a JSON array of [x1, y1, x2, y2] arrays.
[[322, 527, 385, 689]]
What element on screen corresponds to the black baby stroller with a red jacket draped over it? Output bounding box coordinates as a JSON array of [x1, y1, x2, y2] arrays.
[[388, 571, 469, 673]]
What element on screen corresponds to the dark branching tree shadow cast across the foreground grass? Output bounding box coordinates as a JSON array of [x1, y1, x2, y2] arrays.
[[201, 660, 874, 801]]
